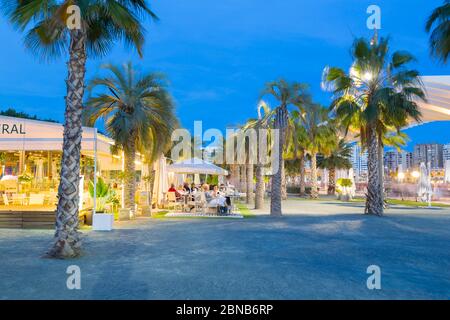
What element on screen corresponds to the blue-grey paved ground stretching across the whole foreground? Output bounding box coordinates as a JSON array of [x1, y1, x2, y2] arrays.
[[0, 200, 450, 299]]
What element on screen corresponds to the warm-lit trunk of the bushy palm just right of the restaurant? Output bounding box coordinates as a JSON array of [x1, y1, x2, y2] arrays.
[[123, 138, 136, 213]]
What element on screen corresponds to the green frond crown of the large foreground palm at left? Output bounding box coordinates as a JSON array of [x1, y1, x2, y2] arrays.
[[2, 0, 158, 59]]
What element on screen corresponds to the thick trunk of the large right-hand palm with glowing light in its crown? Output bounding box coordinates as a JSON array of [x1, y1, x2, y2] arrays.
[[366, 127, 383, 216]]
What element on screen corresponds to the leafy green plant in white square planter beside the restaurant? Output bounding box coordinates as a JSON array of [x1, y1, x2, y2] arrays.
[[89, 177, 114, 231]]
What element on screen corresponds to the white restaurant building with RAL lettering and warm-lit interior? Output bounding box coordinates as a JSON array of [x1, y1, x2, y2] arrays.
[[0, 116, 130, 209]]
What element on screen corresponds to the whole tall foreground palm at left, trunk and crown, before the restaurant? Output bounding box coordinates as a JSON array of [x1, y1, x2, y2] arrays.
[[2, 0, 157, 258]]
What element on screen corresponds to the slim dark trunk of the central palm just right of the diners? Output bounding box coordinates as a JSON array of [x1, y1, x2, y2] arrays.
[[270, 106, 287, 217]]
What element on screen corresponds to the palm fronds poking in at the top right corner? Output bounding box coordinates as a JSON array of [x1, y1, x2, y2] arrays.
[[425, 0, 450, 63]]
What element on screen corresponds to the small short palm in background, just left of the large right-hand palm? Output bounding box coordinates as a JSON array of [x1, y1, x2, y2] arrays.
[[317, 139, 352, 195]]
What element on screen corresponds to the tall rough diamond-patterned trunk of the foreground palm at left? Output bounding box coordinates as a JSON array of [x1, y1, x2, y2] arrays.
[[47, 30, 86, 258]]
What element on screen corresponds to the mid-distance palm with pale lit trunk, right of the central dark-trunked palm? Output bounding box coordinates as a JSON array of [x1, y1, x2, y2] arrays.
[[294, 103, 336, 199]]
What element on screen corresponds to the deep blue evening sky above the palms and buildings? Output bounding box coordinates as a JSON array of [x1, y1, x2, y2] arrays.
[[0, 0, 450, 151]]
